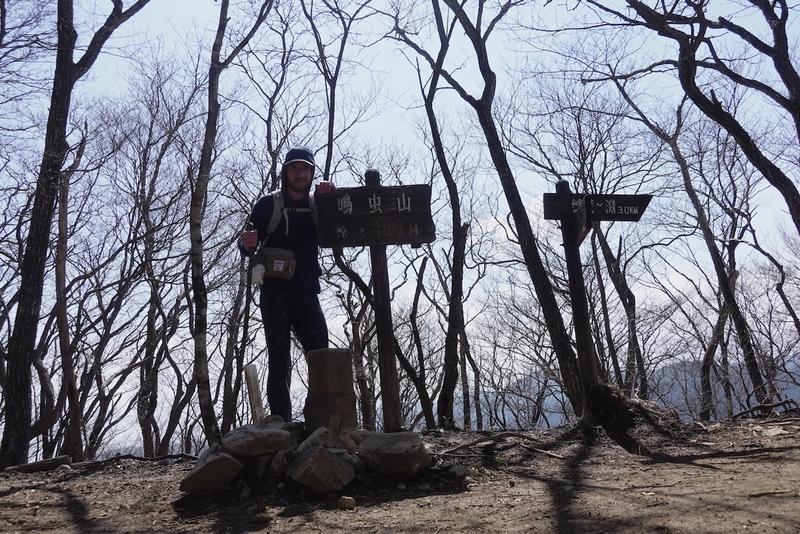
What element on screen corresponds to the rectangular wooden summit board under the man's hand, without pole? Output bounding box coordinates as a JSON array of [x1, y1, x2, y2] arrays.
[[314, 185, 436, 248]]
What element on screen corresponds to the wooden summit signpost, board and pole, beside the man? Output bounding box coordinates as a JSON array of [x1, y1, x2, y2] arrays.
[[314, 169, 436, 432]]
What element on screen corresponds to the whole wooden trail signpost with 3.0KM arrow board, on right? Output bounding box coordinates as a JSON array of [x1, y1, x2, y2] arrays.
[[543, 180, 653, 413]]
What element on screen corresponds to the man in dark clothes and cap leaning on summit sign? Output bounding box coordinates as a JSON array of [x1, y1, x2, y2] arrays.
[[239, 147, 335, 422]]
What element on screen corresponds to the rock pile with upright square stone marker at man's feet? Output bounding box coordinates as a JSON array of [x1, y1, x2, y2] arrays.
[[180, 349, 431, 493]]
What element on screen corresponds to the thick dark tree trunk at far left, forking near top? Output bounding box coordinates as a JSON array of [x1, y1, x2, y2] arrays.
[[0, 0, 150, 467]]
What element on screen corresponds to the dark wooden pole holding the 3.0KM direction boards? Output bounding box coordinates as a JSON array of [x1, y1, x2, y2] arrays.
[[556, 180, 600, 413]]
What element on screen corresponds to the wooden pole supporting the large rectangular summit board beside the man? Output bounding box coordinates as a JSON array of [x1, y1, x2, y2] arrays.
[[364, 169, 403, 432]]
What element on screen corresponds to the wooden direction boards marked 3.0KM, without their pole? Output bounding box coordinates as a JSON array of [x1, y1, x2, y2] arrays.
[[544, 193, 653, 222]]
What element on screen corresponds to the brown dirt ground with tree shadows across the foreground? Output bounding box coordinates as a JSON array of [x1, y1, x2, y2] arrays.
[[0, 412, 800, 533]]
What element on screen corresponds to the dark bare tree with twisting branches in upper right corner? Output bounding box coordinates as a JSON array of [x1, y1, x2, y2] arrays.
[[587, 0, 800, 237]]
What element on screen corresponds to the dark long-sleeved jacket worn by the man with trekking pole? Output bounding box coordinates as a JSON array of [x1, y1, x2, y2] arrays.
[[240, 194, 322, 293]]
